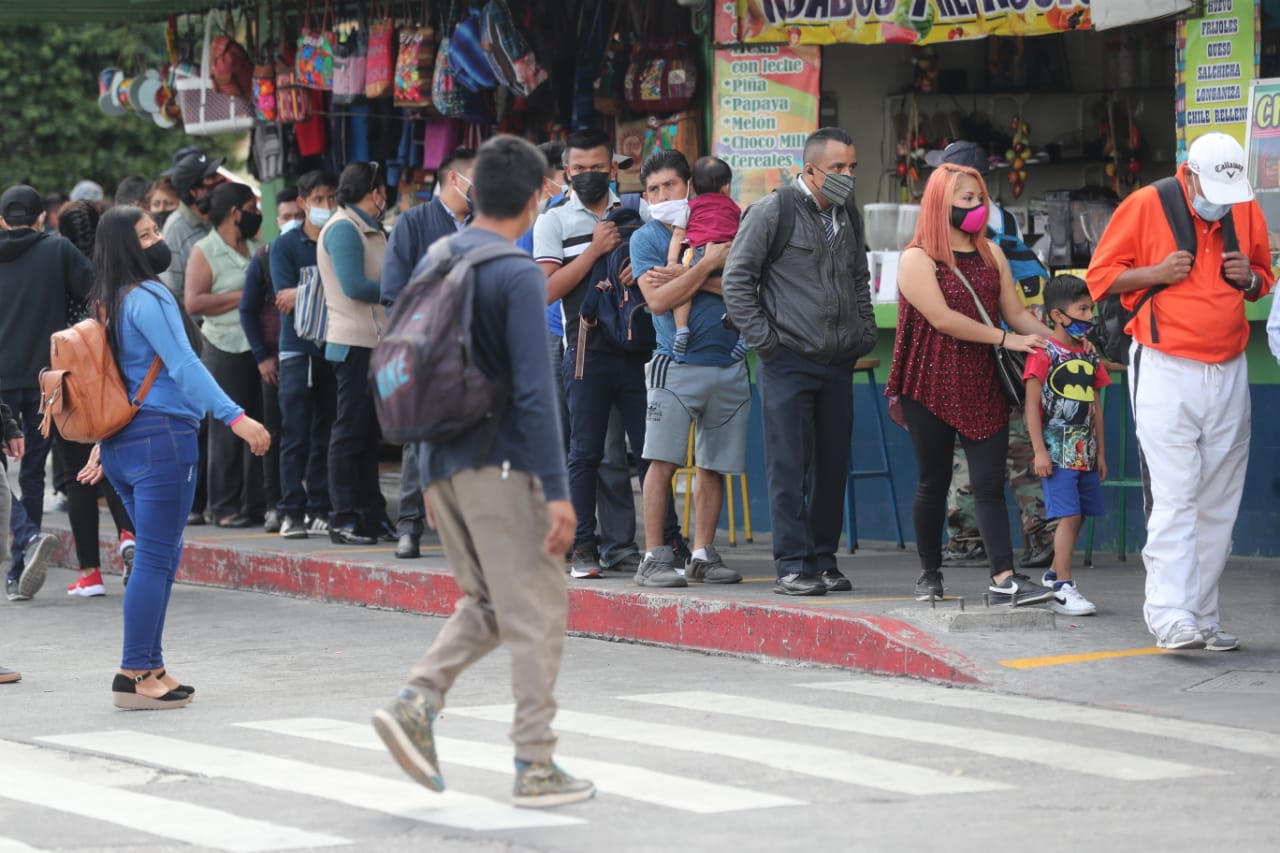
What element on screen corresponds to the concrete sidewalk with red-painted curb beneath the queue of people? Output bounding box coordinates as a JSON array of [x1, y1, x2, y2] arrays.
[[46, 515, 1280, 695]]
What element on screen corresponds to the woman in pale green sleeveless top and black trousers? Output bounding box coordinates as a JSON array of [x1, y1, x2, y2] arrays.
[[184, 183, 266, 528]]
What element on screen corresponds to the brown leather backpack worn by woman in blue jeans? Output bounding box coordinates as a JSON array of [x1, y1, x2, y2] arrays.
[[40, 319, 164, 444]]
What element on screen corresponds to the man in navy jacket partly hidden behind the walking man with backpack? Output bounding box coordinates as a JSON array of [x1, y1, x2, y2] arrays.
[[381, 149, 476, 560]]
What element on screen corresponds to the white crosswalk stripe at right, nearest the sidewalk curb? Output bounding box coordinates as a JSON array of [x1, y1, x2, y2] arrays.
[[799, 680, 1280, 758]]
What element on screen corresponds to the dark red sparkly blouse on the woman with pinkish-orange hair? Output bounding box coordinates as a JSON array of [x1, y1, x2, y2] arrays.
[[884, 252, 1009, 441]]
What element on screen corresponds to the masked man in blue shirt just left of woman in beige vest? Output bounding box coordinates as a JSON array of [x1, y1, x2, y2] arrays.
[[269, 170, 338, 539]]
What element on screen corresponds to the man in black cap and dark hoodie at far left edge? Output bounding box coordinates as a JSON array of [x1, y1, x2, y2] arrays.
[[0, 184, 93, 601]]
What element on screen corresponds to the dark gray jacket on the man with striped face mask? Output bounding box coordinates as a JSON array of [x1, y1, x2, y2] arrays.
[[721, 183, 877, 364]]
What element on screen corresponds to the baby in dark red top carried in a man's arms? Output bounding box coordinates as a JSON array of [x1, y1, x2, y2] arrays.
[[667, 158, 746, 361]]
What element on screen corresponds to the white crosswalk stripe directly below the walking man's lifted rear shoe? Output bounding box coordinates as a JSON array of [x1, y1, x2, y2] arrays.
[[38, 731, 582, 830]]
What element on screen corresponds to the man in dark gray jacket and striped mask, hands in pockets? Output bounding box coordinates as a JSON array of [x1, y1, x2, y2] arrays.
[[722, 127, 876, 596]]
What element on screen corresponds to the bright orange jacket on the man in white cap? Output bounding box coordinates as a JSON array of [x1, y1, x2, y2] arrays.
[[1087, 165, 1275, 364]]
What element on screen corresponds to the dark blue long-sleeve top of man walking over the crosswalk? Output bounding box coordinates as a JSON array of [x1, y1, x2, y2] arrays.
[[419, 228, 568, 501]]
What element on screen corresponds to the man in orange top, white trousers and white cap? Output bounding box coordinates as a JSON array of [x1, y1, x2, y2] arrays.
[[1088, 133, 1274, 651]]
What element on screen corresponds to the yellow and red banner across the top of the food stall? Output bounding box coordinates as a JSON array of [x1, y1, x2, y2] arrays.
[[737, 0, 1093, 45]]
